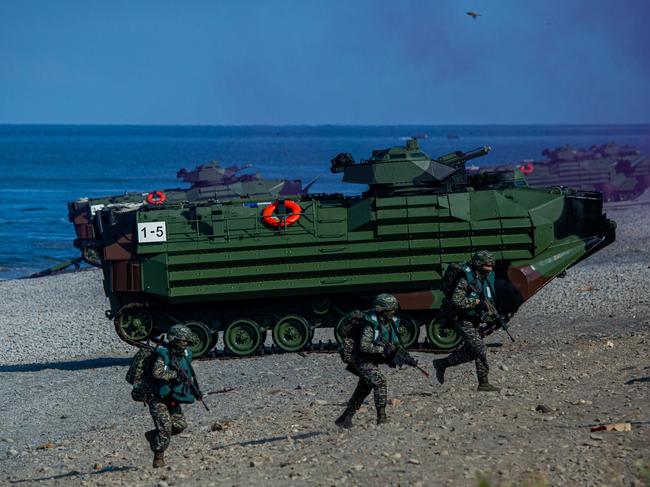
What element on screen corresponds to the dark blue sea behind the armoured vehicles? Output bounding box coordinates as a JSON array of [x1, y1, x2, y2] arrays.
[[0, 125, 650, 279]]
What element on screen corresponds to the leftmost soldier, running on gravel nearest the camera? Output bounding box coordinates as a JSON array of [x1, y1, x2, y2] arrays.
[[145, 325, 195, 468]]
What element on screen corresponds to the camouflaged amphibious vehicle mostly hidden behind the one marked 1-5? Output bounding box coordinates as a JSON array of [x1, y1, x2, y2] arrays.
[[68, 161, 303, 267]]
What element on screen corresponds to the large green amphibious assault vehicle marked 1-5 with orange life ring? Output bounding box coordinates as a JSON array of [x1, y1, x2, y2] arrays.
[[95, 140, 615, 356]]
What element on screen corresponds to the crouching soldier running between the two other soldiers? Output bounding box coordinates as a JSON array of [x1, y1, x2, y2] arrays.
[[336, 294, 399, 428]]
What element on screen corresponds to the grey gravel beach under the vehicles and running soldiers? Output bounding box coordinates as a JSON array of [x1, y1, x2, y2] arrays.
[[0, 205, 650, 487]]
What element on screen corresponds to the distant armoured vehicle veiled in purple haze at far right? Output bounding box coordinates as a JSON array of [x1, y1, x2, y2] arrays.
[[474, 143, 650, 201]]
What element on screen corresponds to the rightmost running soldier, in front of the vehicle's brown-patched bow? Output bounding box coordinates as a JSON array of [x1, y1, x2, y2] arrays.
[[433, 250, 500, 392]]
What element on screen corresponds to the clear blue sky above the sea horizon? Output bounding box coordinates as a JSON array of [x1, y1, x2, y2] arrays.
[[0, 0, 650, 125]]
